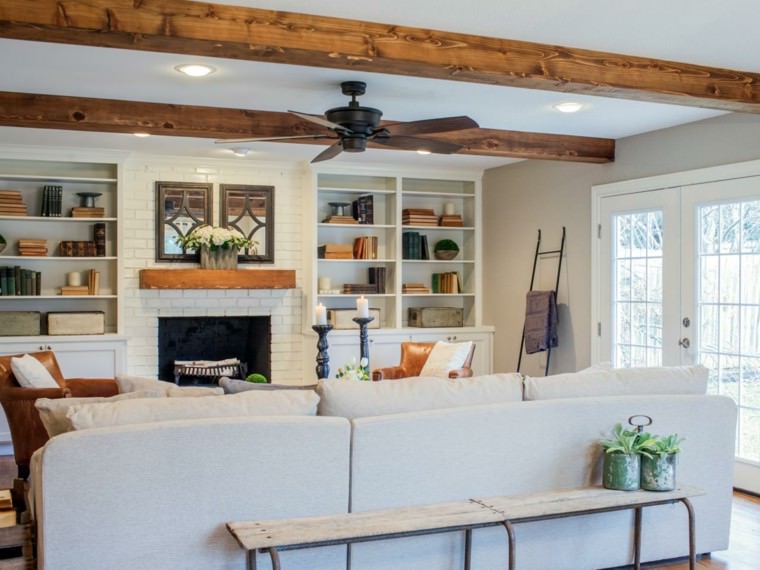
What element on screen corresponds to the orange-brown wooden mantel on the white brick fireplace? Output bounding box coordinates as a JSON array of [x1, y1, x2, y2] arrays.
[[140, 269, 296, 289]]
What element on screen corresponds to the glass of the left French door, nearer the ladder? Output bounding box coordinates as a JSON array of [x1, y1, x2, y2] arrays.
[[611, 210, 663, 367]]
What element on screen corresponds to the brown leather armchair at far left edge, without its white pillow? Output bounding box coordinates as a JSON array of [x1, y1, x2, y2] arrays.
[[0, 351, 119, 479]]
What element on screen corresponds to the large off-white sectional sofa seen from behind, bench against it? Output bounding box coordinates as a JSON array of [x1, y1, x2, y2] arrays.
[[32, 369, 736, 570]]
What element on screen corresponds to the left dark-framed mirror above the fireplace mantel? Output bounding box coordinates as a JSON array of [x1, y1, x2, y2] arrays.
[[156, 182, 213, 261]]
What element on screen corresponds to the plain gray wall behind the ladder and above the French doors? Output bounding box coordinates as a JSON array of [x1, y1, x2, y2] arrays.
[[483, 114, 760, 375]]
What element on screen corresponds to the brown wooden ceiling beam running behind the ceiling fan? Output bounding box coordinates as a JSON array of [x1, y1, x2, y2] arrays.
[[0, 92, 615, 163]]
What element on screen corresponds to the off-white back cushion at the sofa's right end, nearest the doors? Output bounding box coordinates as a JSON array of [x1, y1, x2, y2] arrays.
[[525, 366, 708, 400]]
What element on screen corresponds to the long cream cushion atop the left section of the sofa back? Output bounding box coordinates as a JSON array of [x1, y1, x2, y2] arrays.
[[67, 390, 319, 430]]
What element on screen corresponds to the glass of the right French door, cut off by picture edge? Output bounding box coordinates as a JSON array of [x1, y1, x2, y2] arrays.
[[696, 200, 760, 463]]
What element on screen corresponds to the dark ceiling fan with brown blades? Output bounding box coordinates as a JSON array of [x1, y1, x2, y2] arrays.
[[215, 81, 478, 162]]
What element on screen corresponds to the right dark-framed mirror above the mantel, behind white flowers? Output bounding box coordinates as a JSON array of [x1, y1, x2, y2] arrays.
[[219, 184, 274, 263]]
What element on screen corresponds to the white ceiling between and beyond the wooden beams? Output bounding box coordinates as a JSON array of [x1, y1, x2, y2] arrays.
[[0, 0, 760, 168]]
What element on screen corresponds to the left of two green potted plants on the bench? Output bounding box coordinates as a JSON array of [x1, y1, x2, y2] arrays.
[[601, 423, 655, 491]]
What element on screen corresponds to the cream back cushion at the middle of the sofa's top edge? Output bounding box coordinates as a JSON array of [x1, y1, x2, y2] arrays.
[[317, 373, 522, 418]]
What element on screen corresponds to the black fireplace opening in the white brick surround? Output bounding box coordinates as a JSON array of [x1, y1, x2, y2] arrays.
[[158, 317, 272, 385]]
